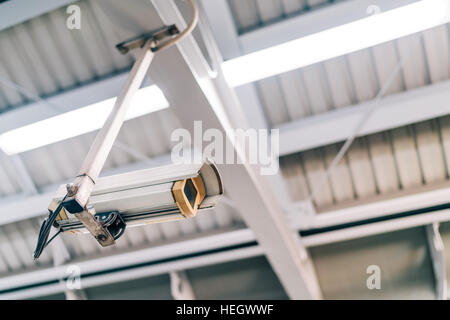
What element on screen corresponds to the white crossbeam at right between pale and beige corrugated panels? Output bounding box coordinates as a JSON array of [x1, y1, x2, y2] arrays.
[[278, 81, 450, 156]]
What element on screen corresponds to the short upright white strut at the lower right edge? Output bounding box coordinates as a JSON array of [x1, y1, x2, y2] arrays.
[[426, 222, 448, 300]]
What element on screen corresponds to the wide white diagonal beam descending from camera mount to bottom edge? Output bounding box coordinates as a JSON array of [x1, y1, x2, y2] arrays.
[[150, 0, 321, 299]]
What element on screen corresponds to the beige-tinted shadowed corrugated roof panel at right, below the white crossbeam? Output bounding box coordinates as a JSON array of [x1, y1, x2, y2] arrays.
[[281, 116, 450, 208]]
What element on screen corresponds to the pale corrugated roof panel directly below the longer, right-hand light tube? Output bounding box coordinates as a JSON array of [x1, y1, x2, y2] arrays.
[[255, 24, 450, 126]]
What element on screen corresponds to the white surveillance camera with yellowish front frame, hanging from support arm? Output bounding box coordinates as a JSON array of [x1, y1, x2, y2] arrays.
[[49, 161, 223, 239]]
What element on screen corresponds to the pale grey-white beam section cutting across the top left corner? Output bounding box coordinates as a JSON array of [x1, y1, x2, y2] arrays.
[[0, 0, 78, 31]]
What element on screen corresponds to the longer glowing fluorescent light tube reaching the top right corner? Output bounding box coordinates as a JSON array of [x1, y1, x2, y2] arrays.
[[222, 0, 450, 87]]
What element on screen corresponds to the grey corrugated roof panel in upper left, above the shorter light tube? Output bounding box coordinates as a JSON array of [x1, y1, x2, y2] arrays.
[[0, 1, 132, 114]]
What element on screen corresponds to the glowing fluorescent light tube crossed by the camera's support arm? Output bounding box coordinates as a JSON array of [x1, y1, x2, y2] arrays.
[[0, 85, 169, 155]]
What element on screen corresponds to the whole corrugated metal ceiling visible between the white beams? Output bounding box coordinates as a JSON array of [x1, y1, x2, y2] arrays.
[[0, 0, 450, 298]]
